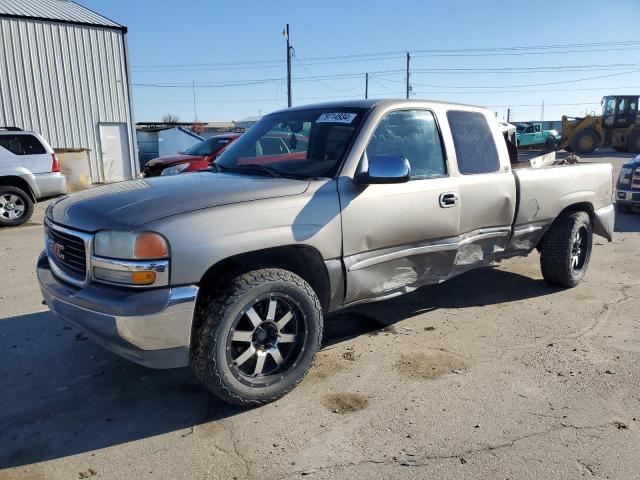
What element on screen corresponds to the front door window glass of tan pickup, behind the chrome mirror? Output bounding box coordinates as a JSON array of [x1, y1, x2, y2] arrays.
[[367, 110, 447, 179]]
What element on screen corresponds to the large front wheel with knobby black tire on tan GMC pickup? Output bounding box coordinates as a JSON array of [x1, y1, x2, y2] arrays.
[[190, 268, 323, 406]]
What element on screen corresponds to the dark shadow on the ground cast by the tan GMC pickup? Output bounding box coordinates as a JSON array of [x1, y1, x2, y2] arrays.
[[0, 268, 556, 469]]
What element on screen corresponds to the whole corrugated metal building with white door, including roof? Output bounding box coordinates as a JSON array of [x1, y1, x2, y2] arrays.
[[0, 0, 139, 183]]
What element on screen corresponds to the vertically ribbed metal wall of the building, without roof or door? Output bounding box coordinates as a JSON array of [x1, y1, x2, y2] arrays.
[[0, 17, 136, 182]]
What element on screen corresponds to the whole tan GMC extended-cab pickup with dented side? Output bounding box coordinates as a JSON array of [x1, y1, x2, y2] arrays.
[[37, 100, 614, 405]]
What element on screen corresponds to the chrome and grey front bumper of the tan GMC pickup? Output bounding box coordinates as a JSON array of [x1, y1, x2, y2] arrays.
[[37, 252, 198, 368]]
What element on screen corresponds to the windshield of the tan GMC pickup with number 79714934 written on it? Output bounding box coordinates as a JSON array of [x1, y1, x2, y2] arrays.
[[214, 107, 367, 178]]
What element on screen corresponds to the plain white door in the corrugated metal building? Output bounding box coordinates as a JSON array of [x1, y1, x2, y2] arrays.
[[99, 123, 131, 183]]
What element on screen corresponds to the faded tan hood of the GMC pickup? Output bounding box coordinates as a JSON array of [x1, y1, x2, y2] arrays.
[[47, 172, 309, 232]]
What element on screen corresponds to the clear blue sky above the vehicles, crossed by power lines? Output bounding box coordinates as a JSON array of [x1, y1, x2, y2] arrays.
[[78, 0, 640, 121]]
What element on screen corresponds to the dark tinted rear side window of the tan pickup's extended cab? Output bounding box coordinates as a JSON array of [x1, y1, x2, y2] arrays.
[[447, 110, 500, 175]]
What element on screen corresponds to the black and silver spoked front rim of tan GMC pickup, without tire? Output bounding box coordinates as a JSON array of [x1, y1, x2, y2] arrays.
[[226, 293, 307, 386]]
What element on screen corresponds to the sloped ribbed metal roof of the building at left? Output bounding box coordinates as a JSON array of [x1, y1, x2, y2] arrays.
[[0, 0, 122, 28]]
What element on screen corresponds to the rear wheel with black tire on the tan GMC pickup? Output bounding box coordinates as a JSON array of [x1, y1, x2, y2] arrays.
[[540, 212, 593, 288]]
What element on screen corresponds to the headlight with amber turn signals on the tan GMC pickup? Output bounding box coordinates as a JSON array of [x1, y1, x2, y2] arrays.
[[91, 230, 169, 287]]
